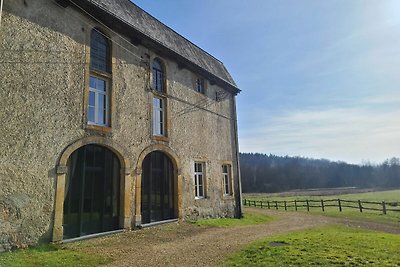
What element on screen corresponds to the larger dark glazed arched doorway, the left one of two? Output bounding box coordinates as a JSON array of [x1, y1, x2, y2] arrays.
[[63, 144, 121, 239]]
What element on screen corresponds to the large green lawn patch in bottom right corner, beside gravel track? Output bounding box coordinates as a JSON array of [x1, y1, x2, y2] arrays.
[[221, 226, 400, 267]]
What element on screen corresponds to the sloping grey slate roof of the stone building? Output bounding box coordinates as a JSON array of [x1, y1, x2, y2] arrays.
[[78, 0, 240, 93]]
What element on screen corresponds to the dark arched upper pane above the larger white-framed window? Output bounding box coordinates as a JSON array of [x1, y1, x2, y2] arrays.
[[90, 29, 111, 73]]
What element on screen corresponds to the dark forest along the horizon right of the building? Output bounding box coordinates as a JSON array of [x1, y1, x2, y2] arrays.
[[240, 153, 400, 193]]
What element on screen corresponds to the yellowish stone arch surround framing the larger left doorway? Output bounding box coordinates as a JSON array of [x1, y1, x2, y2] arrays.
[[52, 136, 132, 242]]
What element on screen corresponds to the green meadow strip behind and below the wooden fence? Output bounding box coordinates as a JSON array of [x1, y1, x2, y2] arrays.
[[244, 190, 400, 225]]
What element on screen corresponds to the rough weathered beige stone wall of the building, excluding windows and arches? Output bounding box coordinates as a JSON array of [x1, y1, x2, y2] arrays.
[[0, 0, 237, 251]]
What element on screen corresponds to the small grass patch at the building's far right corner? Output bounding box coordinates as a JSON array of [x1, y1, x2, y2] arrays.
[[190, 212, 273, 227]]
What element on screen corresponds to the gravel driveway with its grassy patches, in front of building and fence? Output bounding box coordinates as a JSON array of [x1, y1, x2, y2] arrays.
[[0, 208, 400, 267]]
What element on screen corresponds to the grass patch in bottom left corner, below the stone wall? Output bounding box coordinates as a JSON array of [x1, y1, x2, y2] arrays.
[[0, 244, 111, 267]]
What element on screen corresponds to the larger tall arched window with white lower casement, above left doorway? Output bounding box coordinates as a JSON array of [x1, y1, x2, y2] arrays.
[[87, 29, 111, 126]]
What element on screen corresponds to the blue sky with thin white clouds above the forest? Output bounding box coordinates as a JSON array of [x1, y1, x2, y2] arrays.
[[133, 0, 400, 164]]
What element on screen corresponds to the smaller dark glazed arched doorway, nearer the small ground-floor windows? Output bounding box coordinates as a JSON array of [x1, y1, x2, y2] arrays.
[[141, 151, 177, 224]]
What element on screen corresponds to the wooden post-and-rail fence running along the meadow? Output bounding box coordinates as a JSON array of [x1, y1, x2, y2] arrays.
[[243, 199, 400, 214]]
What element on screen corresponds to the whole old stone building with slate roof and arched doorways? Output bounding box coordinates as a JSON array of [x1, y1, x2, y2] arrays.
[[0, 0, 241, 251]]
